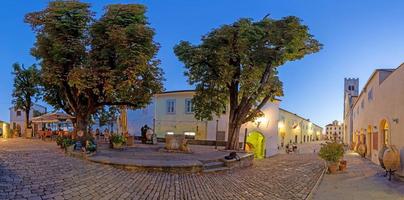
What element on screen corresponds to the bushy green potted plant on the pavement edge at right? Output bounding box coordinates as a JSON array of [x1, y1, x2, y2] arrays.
[[319, 142, 344, 174]]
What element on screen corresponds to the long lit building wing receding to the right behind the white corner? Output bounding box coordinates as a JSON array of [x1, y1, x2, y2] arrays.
[[278, 108, 323, 147]]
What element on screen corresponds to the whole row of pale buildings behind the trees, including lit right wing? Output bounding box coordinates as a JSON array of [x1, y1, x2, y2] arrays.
[[126, 90, 323, 157]]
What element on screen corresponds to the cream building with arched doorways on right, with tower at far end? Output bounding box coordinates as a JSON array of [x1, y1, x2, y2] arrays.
[[344, 64, 404, 175]]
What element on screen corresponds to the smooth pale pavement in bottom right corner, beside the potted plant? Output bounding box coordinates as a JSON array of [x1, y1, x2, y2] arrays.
[[314, 153, 404, 200]]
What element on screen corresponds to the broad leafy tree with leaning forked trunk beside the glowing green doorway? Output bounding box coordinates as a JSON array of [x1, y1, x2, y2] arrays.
[[174, 16, 321, 149]]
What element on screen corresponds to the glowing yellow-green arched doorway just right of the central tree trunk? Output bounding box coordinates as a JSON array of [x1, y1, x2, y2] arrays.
[[246, 131, 265, 158]]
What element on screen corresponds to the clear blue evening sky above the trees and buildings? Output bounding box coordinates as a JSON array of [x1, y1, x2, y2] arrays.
[[0, 0, 404, 125]]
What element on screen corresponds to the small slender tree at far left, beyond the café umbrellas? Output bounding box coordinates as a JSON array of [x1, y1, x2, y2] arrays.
[[12, 63, 41, 128]]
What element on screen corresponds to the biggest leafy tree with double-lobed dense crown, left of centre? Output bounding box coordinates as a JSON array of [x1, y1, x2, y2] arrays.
[[25, 0, 163, 134]]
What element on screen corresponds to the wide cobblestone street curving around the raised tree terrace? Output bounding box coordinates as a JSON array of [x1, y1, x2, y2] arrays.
[[0, 139, 323, 199]]
